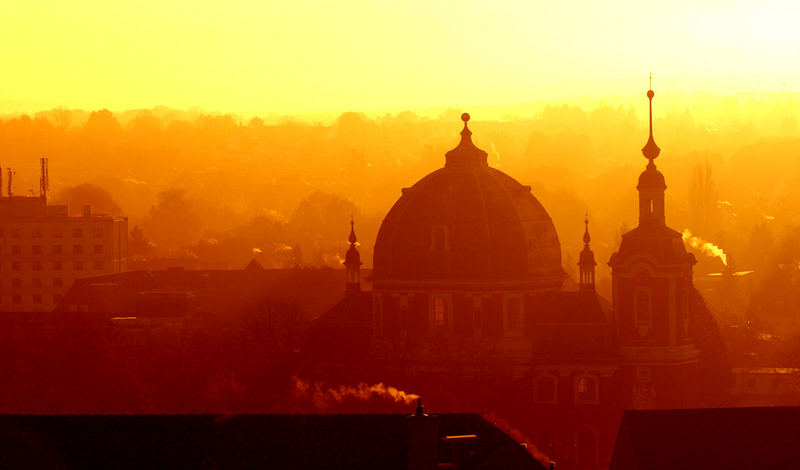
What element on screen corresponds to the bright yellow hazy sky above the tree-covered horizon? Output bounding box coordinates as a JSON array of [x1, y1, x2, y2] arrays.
[[0, 0, 800, 114]]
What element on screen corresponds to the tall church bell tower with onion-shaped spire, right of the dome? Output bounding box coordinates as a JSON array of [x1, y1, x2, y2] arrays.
[[608, 82, 698, 408]]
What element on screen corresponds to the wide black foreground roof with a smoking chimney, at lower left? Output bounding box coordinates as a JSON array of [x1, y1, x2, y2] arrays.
[[0, 400, 547, 470]]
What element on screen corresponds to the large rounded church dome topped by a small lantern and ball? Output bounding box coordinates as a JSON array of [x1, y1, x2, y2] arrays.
[[373, 113, 565, 289]]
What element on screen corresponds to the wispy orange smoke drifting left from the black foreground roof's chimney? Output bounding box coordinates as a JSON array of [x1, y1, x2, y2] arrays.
[[292, 376, 419, 410]]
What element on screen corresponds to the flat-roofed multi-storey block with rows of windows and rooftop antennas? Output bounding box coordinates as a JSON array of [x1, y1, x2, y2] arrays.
[[0, 176, 128, 312]]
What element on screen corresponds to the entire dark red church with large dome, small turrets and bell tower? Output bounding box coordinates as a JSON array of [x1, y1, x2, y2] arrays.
[[319, 90, 698, 469]]
